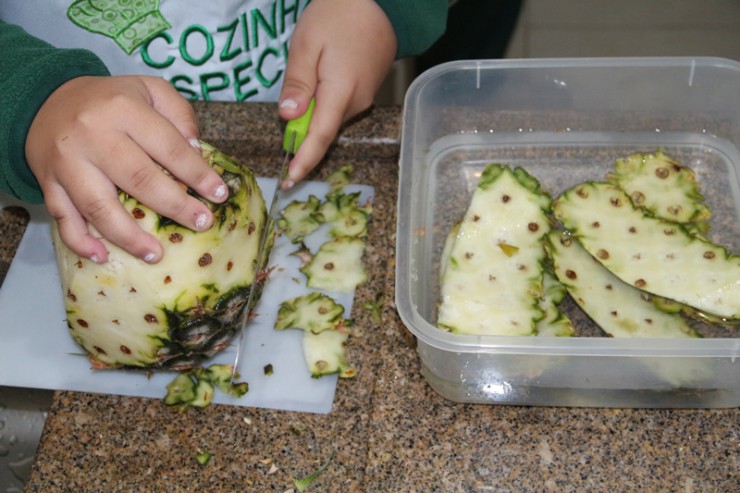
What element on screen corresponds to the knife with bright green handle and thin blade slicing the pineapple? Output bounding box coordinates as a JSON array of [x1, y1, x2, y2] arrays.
[[230, 98, 316, 384]]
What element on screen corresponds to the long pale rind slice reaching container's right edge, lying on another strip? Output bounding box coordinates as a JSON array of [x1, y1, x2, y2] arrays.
[[553, 182, 740, 319]]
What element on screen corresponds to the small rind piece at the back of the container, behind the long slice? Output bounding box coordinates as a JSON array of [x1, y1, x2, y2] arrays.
[[607, 151, 711, 233]]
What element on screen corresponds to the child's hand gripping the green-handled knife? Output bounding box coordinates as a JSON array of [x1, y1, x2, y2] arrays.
[[279, 0, 396, 187]]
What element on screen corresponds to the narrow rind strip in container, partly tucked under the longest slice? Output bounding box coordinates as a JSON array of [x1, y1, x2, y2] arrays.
[[546, 230, 697, 338]]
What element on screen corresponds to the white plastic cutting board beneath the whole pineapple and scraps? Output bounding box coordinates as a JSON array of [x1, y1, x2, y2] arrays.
[[0, 178, 374, 413]]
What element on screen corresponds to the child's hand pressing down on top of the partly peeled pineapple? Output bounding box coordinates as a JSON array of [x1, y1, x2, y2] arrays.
[[26, 76, 228, 263]]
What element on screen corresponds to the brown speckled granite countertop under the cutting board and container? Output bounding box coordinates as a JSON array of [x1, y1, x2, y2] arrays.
[[7, 103, 740, 493]]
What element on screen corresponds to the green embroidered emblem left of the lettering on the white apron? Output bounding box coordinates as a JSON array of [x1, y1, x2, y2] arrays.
[[67, 0, 171, 55]]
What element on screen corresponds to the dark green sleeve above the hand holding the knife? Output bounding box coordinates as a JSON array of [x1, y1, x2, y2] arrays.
[[376, 0, 448, 58]]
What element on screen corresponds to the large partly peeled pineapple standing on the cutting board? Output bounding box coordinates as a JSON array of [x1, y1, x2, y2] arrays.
[[52, 143, 274, 369]]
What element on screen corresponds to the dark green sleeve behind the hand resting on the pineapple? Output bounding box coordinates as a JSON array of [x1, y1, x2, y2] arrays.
[[0, 20, 109, 203]]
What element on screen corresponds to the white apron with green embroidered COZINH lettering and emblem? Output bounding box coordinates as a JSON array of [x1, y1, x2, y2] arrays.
[[0, 0, 309, 101]]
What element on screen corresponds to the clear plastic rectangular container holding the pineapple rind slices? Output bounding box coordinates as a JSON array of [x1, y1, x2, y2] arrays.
[[396, 58, 740, 408]]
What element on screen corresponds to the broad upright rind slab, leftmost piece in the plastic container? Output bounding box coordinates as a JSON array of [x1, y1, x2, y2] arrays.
[[437, 164, 550, 336]]
